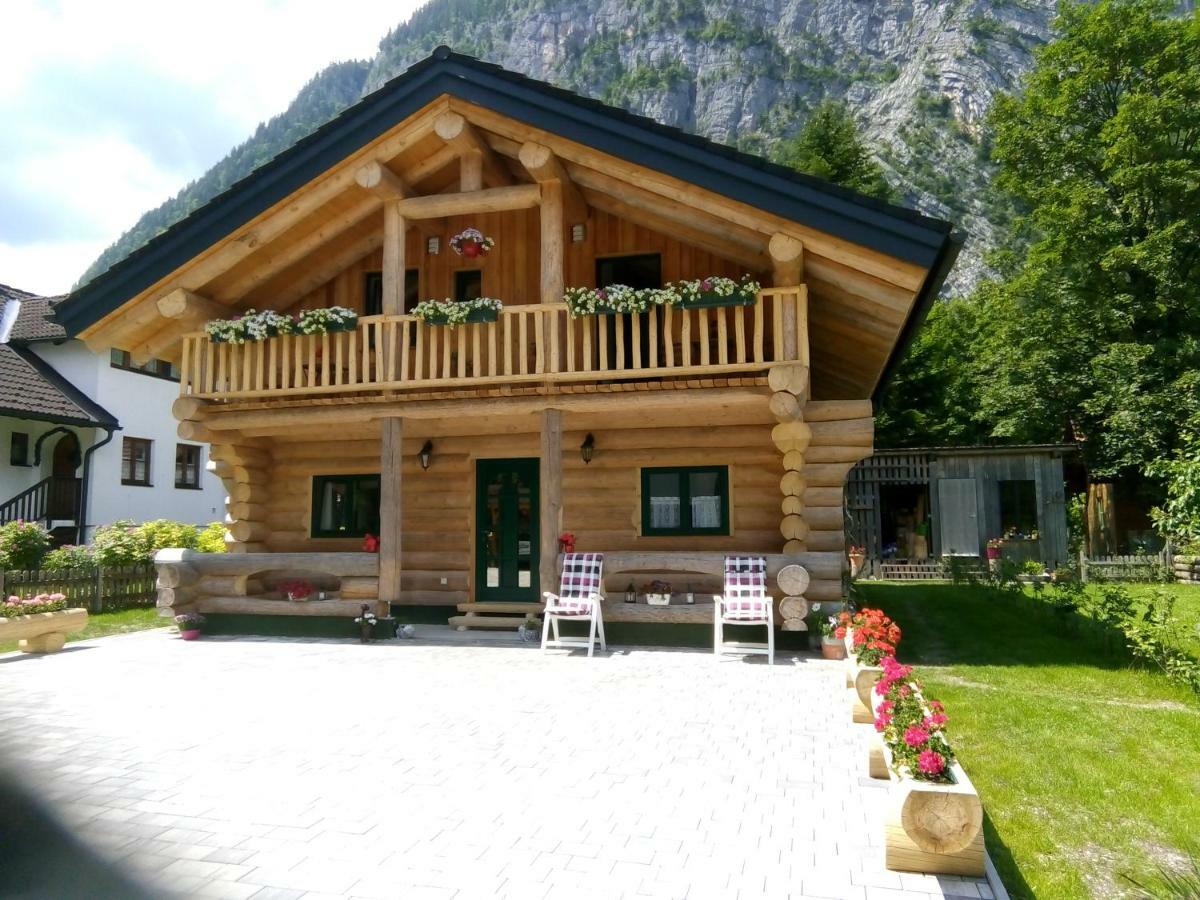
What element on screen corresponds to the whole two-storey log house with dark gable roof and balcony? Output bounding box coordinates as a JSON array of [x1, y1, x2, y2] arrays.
[[56, 48, 960, 629]]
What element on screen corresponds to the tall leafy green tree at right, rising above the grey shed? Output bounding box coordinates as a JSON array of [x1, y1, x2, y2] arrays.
[[972, 0, 1200, 476]]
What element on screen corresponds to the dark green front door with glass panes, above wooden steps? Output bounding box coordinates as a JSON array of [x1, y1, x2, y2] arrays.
[[475, 460, 538, 602]]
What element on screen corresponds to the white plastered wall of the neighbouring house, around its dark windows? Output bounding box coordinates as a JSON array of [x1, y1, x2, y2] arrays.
[[5, 341, 226, 538]]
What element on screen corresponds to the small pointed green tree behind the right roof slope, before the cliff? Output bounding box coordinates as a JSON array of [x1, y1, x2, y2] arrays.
[[775, 100, 892, 200]]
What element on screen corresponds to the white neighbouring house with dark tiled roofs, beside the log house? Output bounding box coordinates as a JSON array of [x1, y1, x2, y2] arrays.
[[0, 284, 226, 542]]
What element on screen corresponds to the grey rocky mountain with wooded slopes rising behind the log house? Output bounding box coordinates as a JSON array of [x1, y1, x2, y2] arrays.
[[84, 0, 1056, 294]]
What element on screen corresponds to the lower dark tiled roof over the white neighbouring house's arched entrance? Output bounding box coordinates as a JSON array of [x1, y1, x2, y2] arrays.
[[0, 344, 119, 428]]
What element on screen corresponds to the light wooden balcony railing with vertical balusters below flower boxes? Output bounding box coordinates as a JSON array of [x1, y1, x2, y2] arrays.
[[180, 286, 808, 400]]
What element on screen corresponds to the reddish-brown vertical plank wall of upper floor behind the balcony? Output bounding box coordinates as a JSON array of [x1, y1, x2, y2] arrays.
[[283, 209, 758, 312]]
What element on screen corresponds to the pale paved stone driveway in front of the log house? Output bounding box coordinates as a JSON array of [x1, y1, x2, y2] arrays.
[[0, 628, 991, 900]]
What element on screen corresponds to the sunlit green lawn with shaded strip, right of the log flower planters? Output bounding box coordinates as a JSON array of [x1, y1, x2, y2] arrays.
[[858, 582, 1200, 898]]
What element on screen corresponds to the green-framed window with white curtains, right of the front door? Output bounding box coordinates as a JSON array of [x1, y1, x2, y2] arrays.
[[642, 466, 730, 536]]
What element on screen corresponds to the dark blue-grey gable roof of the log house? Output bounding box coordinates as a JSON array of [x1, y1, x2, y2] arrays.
[[54, 47, 961, 367]]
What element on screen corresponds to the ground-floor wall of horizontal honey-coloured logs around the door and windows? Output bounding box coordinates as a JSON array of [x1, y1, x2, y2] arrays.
[[248, 412, 871, 609]]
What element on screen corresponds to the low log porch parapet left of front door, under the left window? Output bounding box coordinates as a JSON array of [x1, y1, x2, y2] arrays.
[[155, 550, 388, 618]]
